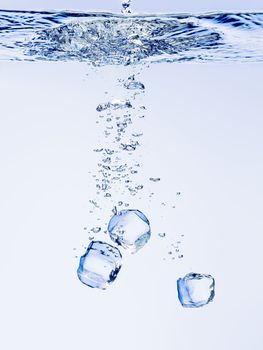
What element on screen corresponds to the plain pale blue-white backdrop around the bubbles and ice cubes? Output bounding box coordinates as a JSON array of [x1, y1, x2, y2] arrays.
[[0, 1, 263, 350]]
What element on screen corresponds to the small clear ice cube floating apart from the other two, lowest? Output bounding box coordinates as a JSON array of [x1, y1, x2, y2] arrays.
[[177, 272, 215, 308]]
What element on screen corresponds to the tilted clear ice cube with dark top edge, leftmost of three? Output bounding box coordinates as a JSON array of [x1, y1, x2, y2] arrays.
[[77, 241, 122, 289]]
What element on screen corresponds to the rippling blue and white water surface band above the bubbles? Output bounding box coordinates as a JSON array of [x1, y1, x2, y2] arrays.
[[0, 9, 263, 66]]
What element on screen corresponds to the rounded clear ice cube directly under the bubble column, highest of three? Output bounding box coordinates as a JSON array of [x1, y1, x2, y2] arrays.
[[108, 209, 151, 254]]
